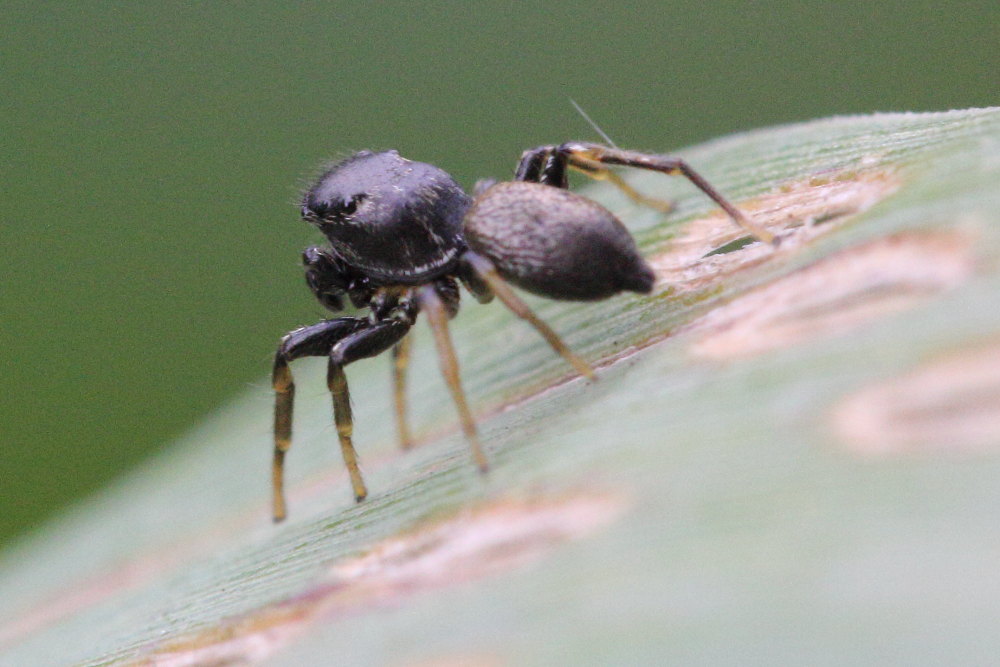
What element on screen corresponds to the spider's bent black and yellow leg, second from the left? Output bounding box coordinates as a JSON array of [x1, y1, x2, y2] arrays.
[[326, 319, 411, 502]]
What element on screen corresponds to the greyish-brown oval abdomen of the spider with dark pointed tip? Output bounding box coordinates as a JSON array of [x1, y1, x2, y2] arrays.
[[463, 181, 655, 301]]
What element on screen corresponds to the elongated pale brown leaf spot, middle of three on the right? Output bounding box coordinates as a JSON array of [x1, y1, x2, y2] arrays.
[[689, 231, 974, 359]]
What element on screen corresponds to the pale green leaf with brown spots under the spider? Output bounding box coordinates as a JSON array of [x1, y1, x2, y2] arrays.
[[0, 109, 1000, 665]]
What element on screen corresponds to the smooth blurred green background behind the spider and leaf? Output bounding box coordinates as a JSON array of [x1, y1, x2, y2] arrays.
[[0, 0, 1000, 540]]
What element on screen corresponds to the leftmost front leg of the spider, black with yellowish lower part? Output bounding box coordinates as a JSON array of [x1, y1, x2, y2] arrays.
[[271, 317, 368, 521]]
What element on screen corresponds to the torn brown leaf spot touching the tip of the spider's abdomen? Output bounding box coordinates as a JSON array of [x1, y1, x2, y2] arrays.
[[649, 171, 899, 293]]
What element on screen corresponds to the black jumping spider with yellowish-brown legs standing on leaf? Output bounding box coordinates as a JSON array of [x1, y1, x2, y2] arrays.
[[272, 142, 775, 521]]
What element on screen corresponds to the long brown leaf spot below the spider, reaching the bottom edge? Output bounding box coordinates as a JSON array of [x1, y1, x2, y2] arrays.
[[141, 493, 627, 666]]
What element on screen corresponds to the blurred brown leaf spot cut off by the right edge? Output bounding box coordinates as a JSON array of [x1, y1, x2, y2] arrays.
[[833, 341, 1000, 454]]
